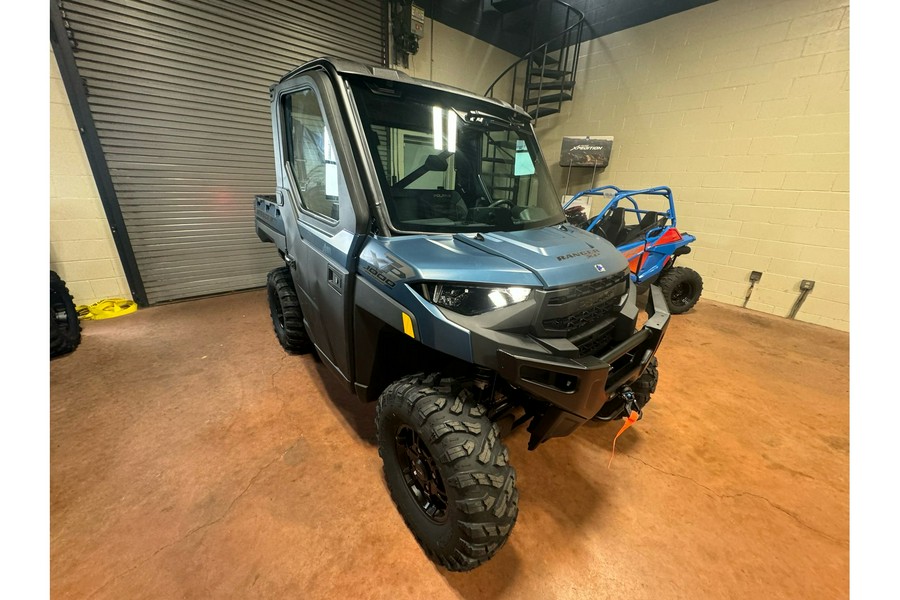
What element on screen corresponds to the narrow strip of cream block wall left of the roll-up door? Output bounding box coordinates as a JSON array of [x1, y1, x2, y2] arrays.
[[50, 48, 131, 304]]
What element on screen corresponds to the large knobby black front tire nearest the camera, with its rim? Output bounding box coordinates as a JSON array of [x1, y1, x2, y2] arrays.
[[375, 374, 519, 571]]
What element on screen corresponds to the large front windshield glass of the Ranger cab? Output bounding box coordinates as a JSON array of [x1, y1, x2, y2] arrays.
[[352, 78, 565, 233]]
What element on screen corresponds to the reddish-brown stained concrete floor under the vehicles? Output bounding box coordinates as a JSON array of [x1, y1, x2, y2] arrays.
[[50, 291, 849, 600]]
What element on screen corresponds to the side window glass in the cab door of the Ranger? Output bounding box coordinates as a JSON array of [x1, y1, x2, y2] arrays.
[[282, 89, 340, 220]]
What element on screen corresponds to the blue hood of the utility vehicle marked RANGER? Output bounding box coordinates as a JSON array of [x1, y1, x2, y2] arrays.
[[370, 226, 628, 288]]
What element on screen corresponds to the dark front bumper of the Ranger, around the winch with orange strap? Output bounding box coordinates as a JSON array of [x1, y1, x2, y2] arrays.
[[497, 285, 669, 449]]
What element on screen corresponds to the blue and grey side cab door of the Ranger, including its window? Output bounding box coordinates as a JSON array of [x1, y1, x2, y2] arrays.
[[274, 73, 365, 383]]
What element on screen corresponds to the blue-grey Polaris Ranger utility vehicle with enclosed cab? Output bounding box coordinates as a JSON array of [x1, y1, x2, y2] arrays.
[[256, 59, 669, 571]]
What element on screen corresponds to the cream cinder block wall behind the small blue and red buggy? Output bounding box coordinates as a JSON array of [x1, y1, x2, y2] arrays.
[[537, 0, 849, 331]]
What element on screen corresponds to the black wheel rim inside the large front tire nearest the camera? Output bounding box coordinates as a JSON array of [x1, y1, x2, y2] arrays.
[[395, 425, 447, 524]]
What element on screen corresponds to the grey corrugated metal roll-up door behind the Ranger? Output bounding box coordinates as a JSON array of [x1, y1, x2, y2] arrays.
[[62, 0, 385, 304]]
